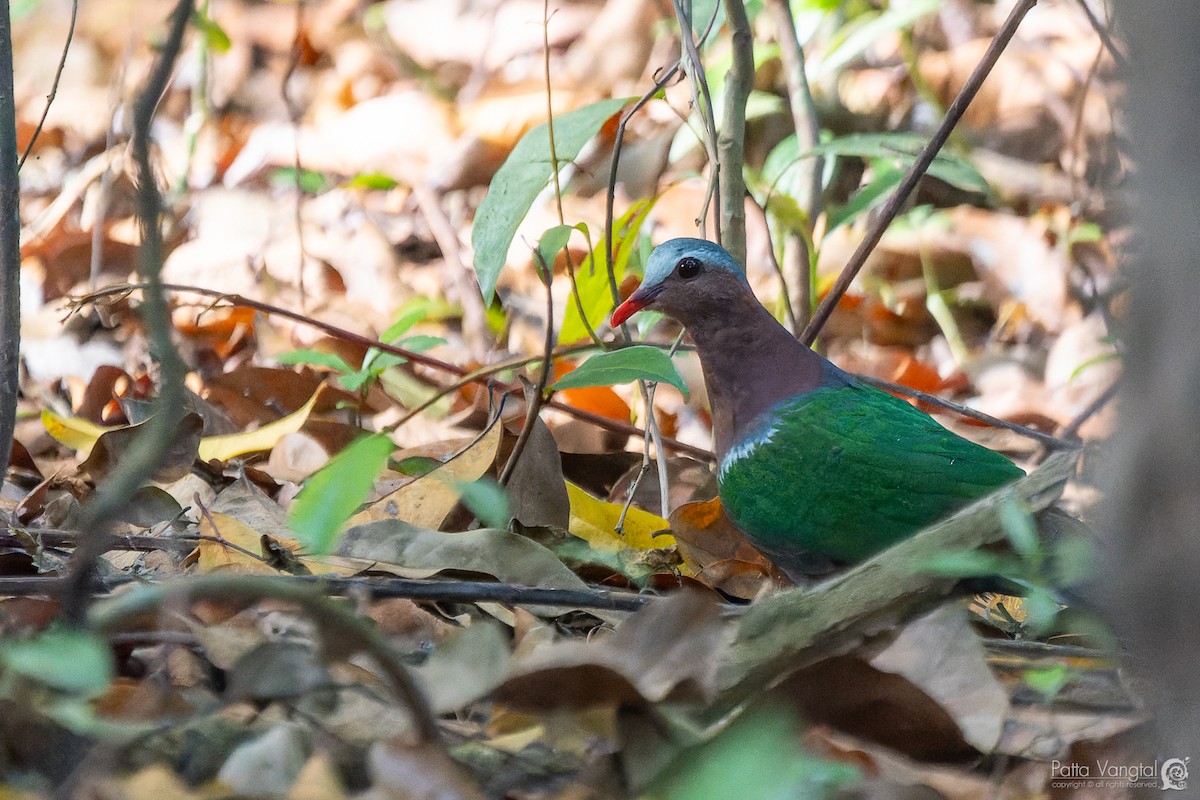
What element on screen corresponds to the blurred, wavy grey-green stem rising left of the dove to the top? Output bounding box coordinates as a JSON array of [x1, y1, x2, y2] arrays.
[[62, 0, 192, 622]]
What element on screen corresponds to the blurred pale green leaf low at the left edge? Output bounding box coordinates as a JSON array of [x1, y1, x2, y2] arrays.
[[0, 625, 115, 697]]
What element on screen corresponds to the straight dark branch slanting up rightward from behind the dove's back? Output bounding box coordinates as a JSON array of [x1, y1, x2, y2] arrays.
[[800, 0, 1038, 345]]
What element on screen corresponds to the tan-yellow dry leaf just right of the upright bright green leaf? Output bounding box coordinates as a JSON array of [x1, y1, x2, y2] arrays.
[[346, 421, 503, 530]]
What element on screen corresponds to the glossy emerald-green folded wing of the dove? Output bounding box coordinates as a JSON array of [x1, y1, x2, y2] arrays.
[[718, 384, 1024, 561]]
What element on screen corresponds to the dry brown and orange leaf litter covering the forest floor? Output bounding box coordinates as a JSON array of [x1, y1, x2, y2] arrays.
[[0, 0, 1145, 799]]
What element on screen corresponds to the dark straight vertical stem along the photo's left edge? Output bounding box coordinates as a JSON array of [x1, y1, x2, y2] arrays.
[[0, 0, 20, 486]]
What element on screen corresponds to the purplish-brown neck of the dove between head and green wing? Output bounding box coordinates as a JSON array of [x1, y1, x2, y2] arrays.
[[690, 295, 841, 459]]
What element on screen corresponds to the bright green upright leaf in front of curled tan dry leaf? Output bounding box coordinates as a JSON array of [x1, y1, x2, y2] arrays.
[[288, 433, 392, 553]]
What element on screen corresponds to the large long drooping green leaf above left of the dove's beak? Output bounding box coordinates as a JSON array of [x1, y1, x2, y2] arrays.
[[470, 98, 629, 305]]
